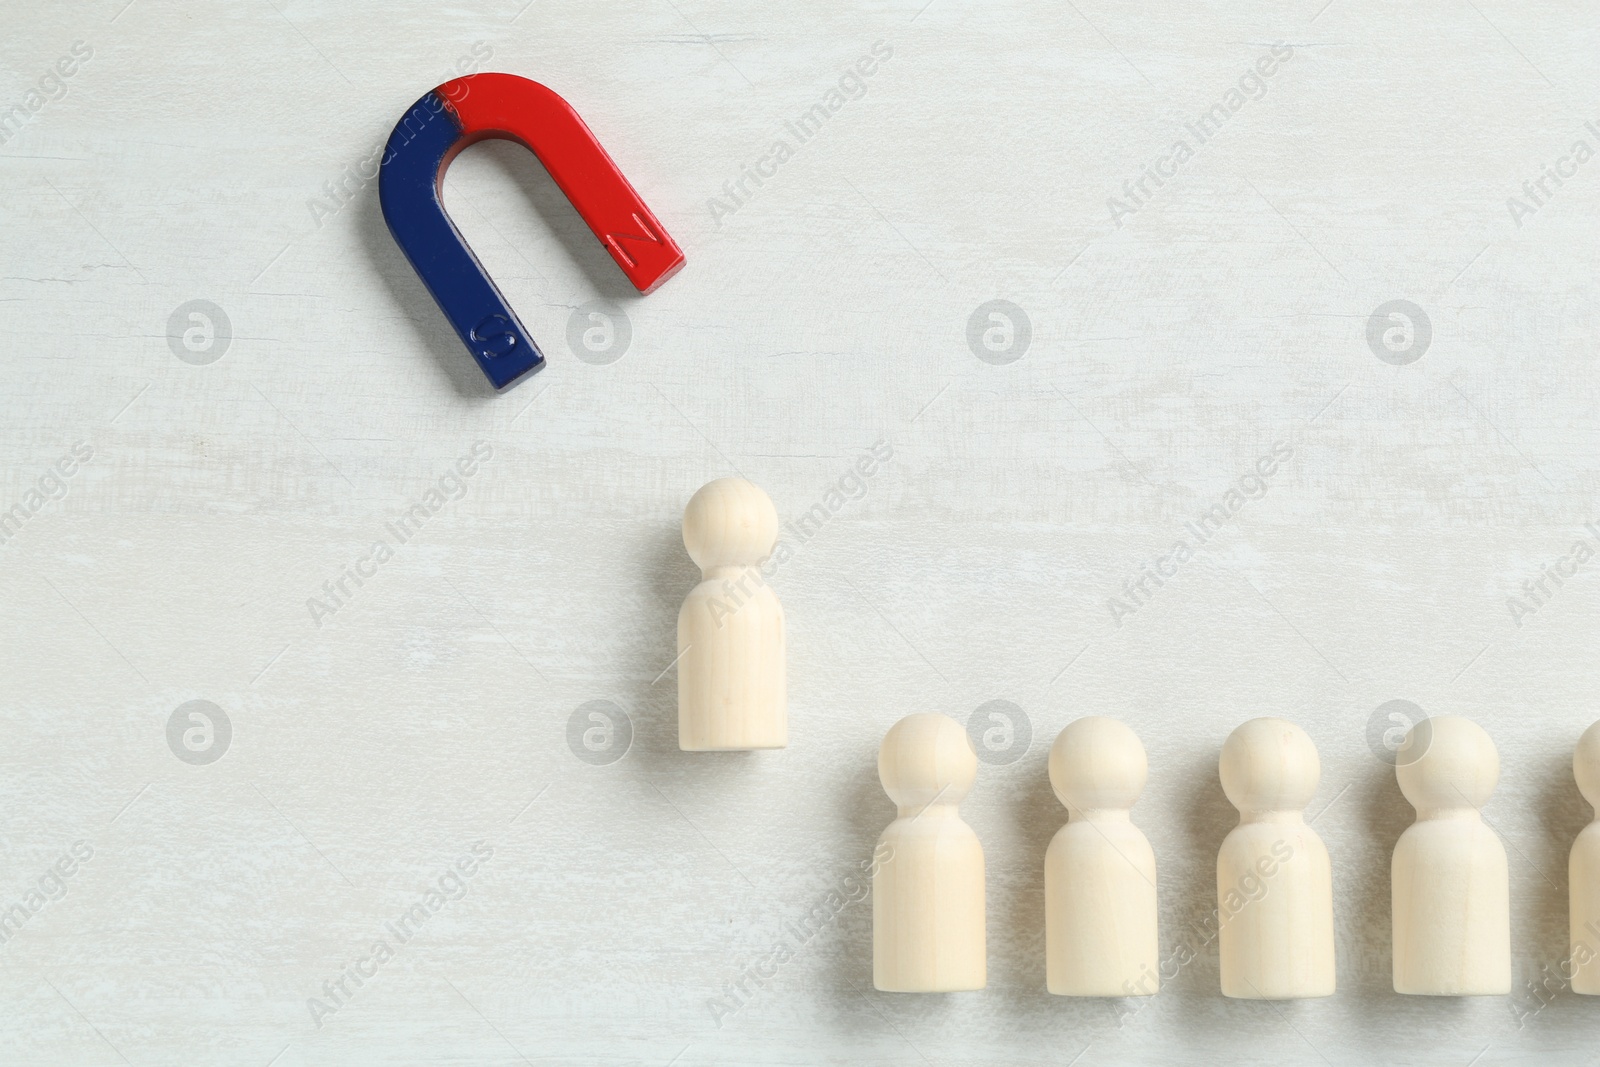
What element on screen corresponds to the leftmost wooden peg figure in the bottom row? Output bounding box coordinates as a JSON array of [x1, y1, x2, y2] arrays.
[[872, 713, 987, 993]]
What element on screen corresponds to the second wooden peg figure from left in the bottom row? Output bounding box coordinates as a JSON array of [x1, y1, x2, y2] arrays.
[[1045, 715, 1160, 997]]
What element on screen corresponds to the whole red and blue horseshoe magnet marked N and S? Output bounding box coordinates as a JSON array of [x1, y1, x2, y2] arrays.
[[378, 74, 683, 390]]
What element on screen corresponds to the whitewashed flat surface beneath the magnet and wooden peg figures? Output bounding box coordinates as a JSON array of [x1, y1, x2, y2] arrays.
[[0, 0, 1600, 1067]]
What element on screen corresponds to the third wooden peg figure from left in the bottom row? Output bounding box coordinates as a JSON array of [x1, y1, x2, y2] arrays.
[[1216, 718, 1334, 1000]]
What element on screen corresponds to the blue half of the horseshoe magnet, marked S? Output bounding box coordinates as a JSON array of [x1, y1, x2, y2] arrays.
[[378, 90, 544, 392]]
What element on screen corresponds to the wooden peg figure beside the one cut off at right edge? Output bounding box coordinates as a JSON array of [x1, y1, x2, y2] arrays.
[[1390, 715, 1510, 997]]
